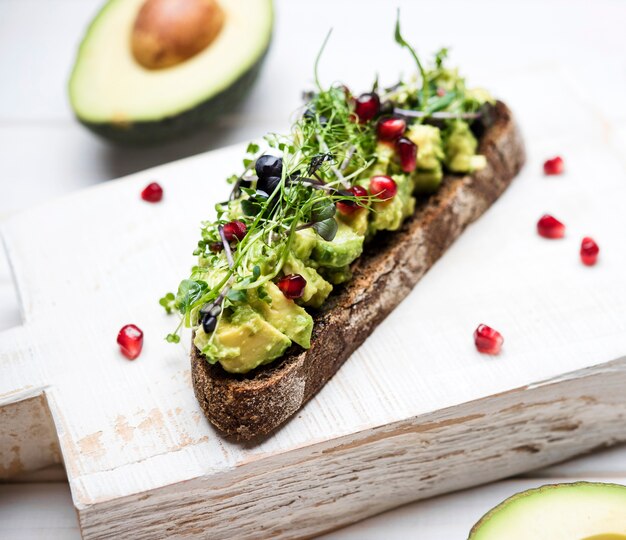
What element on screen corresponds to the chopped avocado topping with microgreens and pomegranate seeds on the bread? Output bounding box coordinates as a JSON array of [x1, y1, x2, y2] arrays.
[[160, 14, 493, 373]]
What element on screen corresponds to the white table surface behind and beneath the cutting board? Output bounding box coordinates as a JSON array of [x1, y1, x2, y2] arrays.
[[0, 0, 626, 540]]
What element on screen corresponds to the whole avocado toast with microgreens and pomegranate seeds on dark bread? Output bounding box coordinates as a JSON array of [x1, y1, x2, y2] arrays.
[[161, 22, 524, 440]]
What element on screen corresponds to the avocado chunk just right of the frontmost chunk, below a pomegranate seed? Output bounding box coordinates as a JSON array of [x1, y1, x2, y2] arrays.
[[248, 282, 313, 349]]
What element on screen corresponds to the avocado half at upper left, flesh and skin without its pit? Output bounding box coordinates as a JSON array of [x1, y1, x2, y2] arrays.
[[69, 0, 273, 144]]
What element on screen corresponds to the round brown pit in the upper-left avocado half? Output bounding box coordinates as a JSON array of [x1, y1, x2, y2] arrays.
[[131, 0, 225, 70]]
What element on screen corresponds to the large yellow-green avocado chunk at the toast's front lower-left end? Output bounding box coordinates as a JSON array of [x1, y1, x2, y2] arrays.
[[194, 305, 291, 373]]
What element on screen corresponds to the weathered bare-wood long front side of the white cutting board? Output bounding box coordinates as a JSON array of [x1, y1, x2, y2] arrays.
[[81, 358, 626, 539]]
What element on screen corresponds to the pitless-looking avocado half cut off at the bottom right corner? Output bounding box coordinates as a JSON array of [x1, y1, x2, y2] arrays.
[[469, 482, 626, 540]]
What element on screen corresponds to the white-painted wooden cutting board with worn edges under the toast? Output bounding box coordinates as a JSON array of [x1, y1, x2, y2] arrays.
[[0, 87, 626, 538]]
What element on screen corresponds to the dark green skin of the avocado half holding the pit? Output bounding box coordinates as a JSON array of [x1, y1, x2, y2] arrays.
[[76, 43, 271, 146]]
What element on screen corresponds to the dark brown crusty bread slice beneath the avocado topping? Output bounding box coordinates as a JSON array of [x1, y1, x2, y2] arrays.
[[191, 102, 525, 440]]
